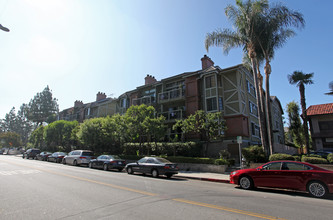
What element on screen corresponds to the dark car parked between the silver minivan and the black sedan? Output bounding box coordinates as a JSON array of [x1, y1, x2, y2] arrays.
[[89, 155, 126, 172]]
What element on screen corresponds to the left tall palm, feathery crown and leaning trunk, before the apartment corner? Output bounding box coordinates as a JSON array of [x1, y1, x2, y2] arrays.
[[205, 0, 269, 153]]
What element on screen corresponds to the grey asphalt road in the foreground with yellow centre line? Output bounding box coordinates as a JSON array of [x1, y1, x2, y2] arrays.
[[0, 155, 333, 220]]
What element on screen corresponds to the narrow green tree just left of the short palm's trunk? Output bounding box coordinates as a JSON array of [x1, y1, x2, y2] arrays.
[[286, 101, 305, 149]]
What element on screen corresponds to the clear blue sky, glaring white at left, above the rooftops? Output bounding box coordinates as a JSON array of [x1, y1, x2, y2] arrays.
[[0, 0, 333, 121]]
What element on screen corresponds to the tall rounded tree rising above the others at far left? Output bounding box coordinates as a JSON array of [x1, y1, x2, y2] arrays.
[[25, 86, 59, 127]]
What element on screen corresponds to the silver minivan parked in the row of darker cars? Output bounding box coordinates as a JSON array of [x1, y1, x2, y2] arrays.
[[62, 150, 95, 166]]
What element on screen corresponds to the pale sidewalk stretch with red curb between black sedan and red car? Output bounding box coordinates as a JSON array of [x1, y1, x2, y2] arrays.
[[175, 171, 230, 183]]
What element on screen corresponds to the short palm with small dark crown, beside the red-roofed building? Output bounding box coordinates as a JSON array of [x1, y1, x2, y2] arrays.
[[288, 71, 314, 153]]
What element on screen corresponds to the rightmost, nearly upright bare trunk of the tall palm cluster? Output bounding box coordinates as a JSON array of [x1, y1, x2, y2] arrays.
[[264, 60, 273, 155]]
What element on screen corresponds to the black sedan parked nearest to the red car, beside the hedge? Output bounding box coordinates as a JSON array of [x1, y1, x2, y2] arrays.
[[125, 157, 178, 178]]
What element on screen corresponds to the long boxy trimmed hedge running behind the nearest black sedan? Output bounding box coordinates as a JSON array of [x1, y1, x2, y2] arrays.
[[122, 142, 202, 157]]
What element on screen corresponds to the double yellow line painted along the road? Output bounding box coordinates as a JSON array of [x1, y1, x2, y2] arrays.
[[7, 161, 285, 220]]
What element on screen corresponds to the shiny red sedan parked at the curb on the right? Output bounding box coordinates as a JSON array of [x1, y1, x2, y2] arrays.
[[230, 161, 333, 198]]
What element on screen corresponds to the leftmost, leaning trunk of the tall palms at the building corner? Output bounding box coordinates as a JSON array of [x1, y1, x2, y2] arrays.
[[249, 55, 267, 153]]
